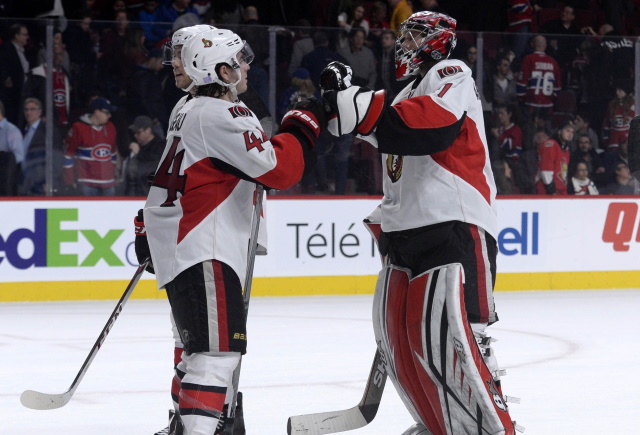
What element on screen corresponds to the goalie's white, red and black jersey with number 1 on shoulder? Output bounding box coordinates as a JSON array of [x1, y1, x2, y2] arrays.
[[375, 60, 497, 237]]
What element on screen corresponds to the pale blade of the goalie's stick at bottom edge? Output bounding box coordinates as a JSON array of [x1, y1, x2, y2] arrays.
[[287, 406, 369, 435]]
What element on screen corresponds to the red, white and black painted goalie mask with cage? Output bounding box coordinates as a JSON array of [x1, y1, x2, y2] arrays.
[[396, 11, 456, 80]]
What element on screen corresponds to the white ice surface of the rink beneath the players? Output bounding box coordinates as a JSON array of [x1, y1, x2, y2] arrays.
[[0, 290, 640, 435]]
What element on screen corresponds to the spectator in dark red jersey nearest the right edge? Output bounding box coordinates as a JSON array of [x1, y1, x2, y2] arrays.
[[602, 79, 636, 150]]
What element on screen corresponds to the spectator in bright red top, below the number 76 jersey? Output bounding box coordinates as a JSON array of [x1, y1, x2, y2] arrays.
[[536, 122, 574, 195]]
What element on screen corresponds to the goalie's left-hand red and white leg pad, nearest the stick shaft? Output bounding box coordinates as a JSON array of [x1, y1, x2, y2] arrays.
[[373, 266, 444, 435]]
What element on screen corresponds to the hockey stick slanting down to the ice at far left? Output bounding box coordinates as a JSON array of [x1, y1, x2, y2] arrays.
[[20, 259, 149, 410]]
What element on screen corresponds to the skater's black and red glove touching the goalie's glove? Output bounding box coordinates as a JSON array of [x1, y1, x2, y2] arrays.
[[279, 98, 327, 148]]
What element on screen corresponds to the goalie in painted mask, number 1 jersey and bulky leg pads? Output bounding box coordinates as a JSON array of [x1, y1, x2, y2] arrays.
[[321, 12, 514, 435]]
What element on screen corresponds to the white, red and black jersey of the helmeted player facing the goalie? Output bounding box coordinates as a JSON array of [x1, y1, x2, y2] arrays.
[[144, 97, 304, 288]]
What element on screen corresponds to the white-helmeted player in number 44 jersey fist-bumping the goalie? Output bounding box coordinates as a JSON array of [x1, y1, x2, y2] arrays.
[[136, 28, 324, 435]]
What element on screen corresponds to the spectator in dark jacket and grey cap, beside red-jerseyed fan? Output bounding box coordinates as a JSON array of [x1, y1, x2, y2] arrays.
[[123, 115, 164, 196]]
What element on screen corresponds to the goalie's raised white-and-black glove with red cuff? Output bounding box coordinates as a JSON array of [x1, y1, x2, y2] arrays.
[[320, 62, 386, 136]]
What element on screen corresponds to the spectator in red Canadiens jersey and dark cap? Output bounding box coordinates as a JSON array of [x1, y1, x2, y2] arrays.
[[63, 97, 118, 196]]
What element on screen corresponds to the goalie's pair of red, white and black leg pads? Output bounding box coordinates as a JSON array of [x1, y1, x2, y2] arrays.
[[373, 263, 520, 435]]
